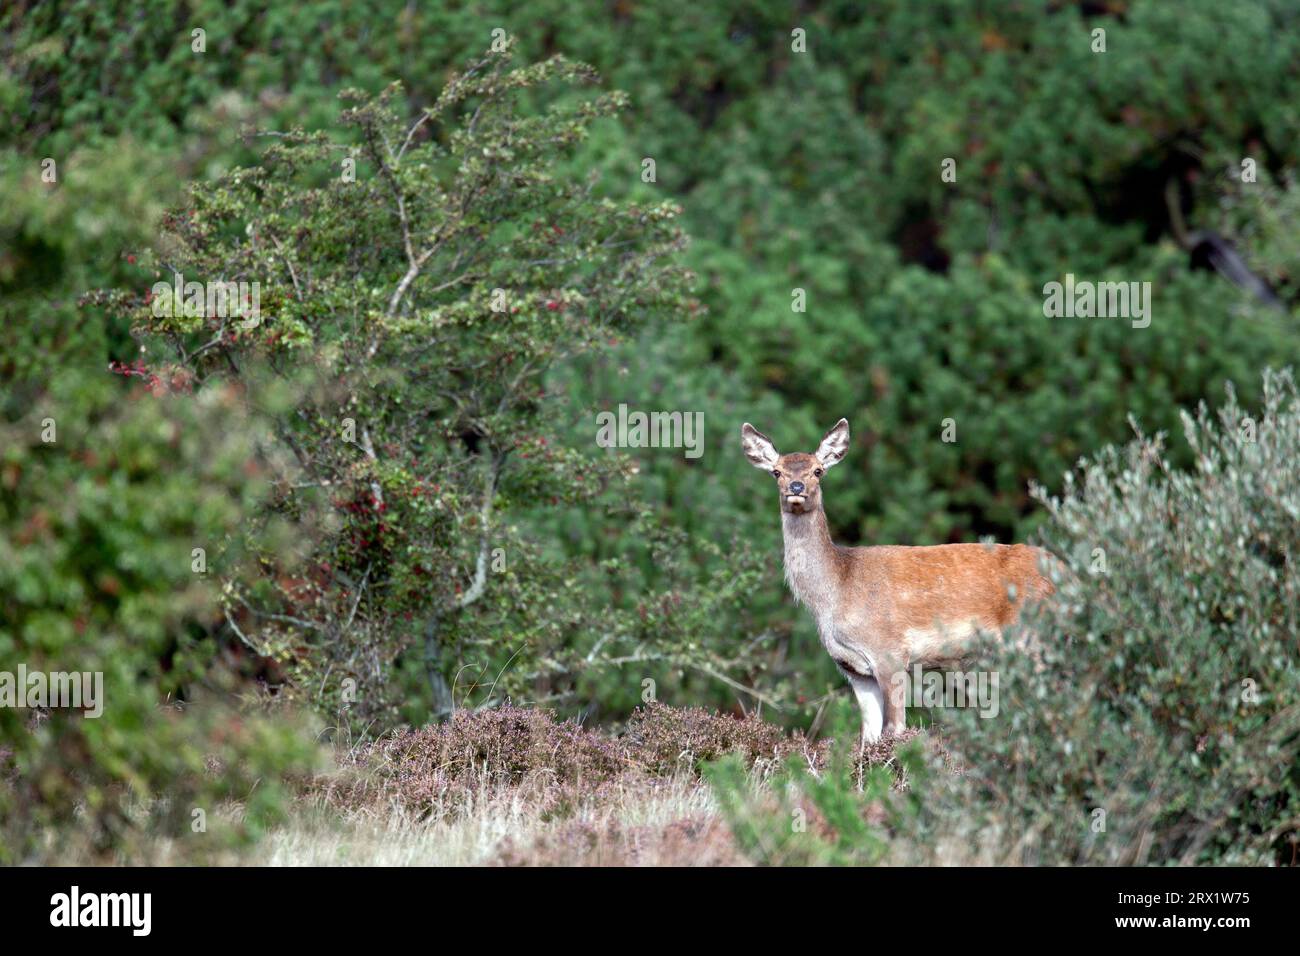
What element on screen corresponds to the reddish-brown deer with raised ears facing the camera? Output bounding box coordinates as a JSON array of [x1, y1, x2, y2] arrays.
[[741, 419, 1054, 748]]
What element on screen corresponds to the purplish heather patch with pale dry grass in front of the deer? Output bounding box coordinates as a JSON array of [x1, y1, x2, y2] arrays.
[[289, 704, 919, 866]]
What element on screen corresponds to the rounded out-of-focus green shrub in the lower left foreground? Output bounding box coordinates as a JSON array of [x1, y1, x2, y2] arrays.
[[0, 369, 316, 862]]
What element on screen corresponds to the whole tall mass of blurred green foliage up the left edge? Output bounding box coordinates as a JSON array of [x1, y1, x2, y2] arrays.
[[0, 115, 322, 862]]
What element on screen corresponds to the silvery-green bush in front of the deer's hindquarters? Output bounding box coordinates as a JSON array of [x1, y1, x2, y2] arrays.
[[945, 372, 1300, 864]]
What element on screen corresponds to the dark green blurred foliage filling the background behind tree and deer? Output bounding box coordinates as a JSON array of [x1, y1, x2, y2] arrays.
[[10, 0, 1300, 710]]
